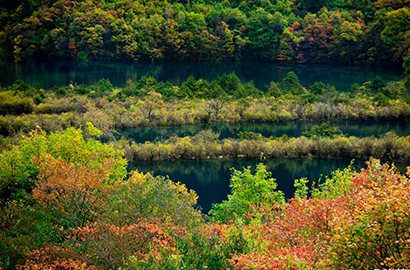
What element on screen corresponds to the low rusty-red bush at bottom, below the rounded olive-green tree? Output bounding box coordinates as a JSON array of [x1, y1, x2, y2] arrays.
[[71, 221, 176, 269]]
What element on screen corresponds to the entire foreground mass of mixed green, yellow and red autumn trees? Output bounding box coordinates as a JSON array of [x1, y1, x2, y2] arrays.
[[0, 127, 410, 270]]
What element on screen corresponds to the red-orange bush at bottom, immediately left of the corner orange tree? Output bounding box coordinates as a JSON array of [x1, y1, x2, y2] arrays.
[[231, 197, 335, 269]]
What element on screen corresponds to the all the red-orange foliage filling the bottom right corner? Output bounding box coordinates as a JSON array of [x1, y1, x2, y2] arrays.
[[230, 160, 410, 269]]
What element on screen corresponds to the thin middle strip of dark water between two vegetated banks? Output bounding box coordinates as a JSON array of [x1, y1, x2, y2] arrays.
[[118, 121, 410, 143]]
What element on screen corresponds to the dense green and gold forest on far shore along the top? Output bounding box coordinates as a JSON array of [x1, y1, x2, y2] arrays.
[[0, 0, 410, 70]]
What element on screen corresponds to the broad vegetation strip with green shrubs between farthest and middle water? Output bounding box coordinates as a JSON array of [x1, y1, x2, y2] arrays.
[[0, 72, 410, 151]]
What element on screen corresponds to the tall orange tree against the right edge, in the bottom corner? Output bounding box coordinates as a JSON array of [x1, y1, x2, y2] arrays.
[[330, 160, 410, 269]]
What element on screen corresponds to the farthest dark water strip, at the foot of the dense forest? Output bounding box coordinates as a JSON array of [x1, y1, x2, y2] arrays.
[[0, 57, 402, 91]]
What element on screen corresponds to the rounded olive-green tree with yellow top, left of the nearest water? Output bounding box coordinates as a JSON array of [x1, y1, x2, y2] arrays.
[[103, 171, 200, 226]]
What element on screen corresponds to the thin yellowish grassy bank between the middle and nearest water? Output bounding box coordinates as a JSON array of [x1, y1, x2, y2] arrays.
[[117, 130, 410, 161]]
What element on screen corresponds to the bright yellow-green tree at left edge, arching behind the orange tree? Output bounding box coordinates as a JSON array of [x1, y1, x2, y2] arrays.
[[0, 128, 127, 207]]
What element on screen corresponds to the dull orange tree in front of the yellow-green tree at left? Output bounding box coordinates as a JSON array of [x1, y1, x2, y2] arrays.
[[33, 154, 111, 226]]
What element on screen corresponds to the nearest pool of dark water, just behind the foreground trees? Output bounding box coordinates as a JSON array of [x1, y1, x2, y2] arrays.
[[129, 158, 365, 213]]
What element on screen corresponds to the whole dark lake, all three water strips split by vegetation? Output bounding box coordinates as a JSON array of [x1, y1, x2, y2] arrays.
[[0, 57, 410, 213]]
